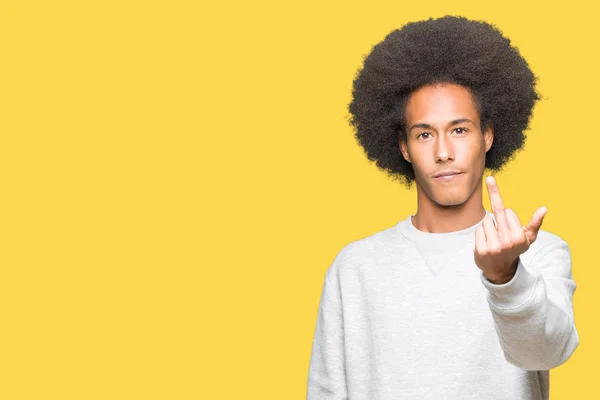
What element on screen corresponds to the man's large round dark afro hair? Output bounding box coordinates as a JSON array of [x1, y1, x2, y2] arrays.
[[348, 15, 541, 188]]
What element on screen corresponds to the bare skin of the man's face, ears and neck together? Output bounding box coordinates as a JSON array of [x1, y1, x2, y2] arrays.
[[400, 83, 494, 233]]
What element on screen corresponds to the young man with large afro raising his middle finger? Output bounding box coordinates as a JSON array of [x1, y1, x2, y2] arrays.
[[307, 16, 579, 400]]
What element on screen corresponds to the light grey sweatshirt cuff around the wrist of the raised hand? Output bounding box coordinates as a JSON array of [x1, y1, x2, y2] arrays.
[[480, 258, 539, 310]]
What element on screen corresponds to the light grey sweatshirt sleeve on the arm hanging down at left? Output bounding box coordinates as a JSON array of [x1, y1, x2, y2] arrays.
[[306, 269, 348, 400]]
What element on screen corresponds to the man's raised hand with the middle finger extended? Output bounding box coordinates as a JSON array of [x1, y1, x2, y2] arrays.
[[474, 176, 548, 284]]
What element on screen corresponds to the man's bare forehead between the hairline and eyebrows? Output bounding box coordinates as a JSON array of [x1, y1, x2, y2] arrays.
[[406, 83, 478, 125]]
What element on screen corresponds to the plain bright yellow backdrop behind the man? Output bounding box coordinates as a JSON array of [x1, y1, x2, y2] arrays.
[[0, 0, 600, 400]]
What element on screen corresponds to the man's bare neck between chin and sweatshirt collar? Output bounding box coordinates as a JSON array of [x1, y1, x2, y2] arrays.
[[412, 177, 486, 233]]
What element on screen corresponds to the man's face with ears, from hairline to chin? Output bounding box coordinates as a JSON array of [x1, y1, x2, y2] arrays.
[[400, 83, 493, 206]]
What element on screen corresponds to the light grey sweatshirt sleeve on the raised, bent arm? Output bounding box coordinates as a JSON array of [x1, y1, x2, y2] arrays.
[[481, 236, 579, 371]]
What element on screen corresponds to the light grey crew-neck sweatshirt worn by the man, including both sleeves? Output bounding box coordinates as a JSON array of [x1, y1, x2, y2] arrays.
[[307, 210, 579, 400]]
